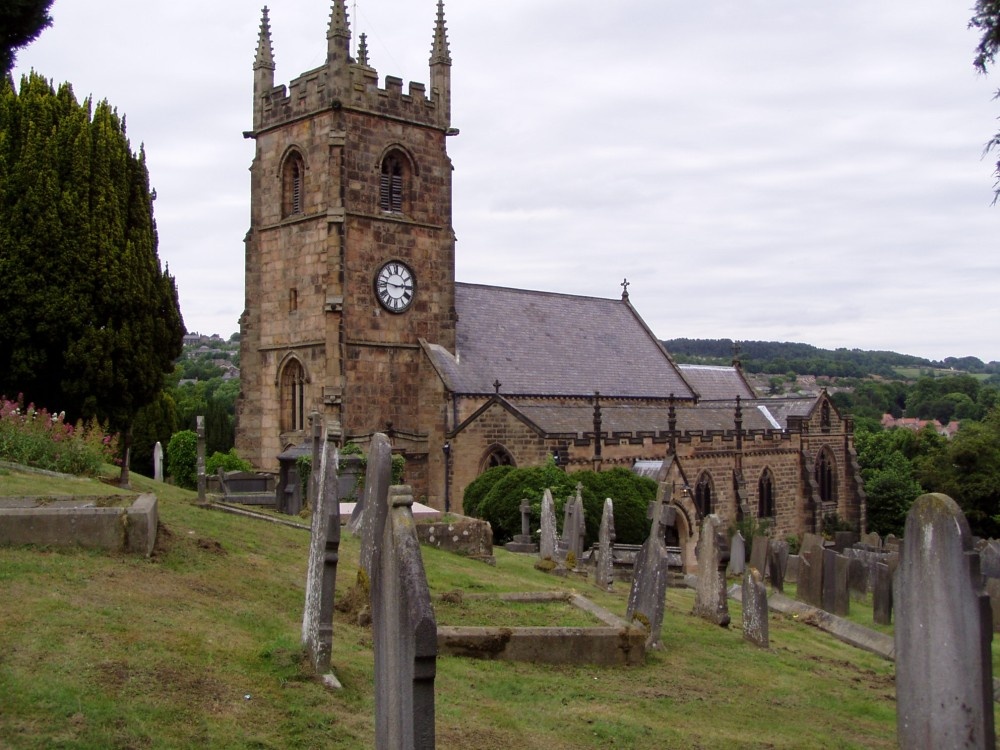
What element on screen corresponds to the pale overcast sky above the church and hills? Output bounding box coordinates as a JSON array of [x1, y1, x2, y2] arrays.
[[9, 0, 1000, 361]]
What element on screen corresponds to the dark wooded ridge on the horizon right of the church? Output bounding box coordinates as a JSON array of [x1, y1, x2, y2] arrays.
[[663, 338, 1000, 378]]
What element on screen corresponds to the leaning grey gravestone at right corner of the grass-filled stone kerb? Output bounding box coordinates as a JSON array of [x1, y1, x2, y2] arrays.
[[625, 482, 677, 648]]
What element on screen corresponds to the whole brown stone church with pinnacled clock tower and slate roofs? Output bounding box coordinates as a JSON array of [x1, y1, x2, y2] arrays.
[[236, 0, 865, 554]]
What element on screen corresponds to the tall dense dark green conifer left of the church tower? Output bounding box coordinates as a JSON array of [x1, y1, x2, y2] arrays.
[[0, 73, 184, 478]]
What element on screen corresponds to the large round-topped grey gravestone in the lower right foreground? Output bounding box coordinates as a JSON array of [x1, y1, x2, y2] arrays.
[[893, 493, 995, 748]]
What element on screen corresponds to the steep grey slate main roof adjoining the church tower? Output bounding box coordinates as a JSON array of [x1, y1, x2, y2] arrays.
[[425, 283, 693, 400]]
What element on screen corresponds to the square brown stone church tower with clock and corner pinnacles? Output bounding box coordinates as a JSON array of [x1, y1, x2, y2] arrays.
[[236, 0, 457, 482]]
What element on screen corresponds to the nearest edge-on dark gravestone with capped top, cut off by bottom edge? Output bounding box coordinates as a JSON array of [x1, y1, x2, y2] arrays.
[[367, 484, 437, 750]]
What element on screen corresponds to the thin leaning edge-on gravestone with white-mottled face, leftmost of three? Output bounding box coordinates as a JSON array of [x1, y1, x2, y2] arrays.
[[302, 434, 340, 684]]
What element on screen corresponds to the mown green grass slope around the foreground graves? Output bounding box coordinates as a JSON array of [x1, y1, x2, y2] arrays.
[[0, 476, 895, 750]]
